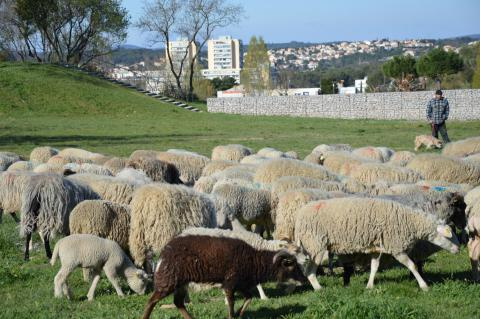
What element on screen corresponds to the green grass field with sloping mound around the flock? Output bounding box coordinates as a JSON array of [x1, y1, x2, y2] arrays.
[[0, 63, 480, 318]]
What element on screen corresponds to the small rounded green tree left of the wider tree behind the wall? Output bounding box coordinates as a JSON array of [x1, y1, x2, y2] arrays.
[[382, 55, 417, 91]]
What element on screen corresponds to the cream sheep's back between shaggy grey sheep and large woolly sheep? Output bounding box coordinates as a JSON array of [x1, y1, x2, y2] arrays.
[[69, 174, 143, 205]]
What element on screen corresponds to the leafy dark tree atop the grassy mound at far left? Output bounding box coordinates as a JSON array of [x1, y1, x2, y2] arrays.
[[12, 0, 128, 65]]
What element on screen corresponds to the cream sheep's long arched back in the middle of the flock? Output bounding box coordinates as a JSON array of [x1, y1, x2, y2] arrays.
[[254, 159, 337, 184]]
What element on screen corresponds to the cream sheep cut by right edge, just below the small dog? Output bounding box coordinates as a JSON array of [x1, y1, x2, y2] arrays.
[[407, 154, 480, 186]]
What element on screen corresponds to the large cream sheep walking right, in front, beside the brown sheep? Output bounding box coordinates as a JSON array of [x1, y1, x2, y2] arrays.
[[295, 198, 459, 290]]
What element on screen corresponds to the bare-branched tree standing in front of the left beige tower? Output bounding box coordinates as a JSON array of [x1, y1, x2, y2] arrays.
[[136, 0, 243, 99]]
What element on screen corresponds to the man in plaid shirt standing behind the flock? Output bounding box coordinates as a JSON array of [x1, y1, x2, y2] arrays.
[[427, 90, 450, 143]]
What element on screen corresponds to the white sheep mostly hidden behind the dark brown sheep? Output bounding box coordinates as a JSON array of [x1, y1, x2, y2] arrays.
[[180, 228, 309, 300]]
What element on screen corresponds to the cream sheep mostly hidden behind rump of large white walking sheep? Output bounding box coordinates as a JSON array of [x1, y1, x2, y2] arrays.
[[273, 188, 332, 242]]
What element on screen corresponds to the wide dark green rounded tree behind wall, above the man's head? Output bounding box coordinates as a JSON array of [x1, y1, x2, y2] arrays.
[[417, 48, 463, 79]]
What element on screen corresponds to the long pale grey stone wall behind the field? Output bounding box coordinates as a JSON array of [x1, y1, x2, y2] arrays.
[[207, 90, 480, 121]]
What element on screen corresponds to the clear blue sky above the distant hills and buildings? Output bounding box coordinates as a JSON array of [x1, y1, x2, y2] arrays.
[[122, 0, 480, 47]]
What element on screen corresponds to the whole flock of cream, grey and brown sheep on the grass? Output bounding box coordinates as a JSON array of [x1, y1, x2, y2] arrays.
[[0, 137, 480, 318]]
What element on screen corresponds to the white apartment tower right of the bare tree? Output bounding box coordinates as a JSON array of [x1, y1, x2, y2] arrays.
[[202, 36, 243, 83]]
